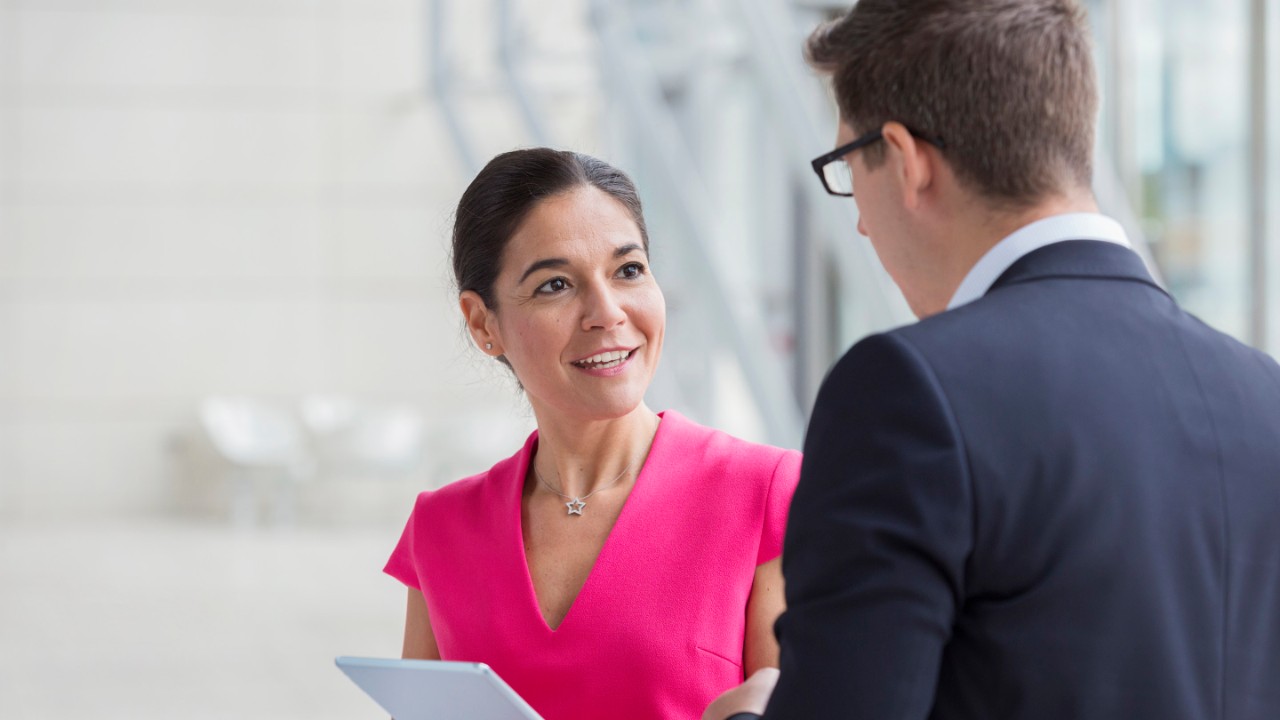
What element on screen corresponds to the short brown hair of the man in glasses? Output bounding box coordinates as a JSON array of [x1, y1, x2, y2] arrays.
[[805, 0, 1098, 206]]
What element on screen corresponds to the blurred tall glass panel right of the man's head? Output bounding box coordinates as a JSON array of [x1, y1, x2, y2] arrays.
[[1117, 0, 1249, 338]]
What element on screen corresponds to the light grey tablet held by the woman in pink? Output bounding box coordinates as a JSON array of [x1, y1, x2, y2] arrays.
[[334, 657, 543, 720]]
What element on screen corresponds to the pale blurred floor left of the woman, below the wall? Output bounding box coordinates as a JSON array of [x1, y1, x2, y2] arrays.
[[0, 519, 404, 720]]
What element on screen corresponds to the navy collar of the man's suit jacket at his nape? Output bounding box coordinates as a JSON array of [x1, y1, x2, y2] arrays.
[[988, 240, 1165, 292]]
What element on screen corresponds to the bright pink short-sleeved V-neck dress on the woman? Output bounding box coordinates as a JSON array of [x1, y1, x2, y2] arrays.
[[387, 411, 800, 720]]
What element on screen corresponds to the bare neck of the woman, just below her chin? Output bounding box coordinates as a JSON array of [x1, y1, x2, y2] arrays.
[[532, 402, 659, 497]]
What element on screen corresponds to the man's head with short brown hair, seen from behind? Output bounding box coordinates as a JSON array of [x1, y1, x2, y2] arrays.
[[806, 0, 1097, 316]]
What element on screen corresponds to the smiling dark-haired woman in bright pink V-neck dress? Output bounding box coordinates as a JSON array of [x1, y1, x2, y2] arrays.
[[387, 149, 800, 720]]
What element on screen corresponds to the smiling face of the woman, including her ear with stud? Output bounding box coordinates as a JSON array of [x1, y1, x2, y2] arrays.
[[462, 186, 667, 420]]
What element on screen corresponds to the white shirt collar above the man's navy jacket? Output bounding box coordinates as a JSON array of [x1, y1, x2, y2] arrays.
[[947, 213, 1130, 310]]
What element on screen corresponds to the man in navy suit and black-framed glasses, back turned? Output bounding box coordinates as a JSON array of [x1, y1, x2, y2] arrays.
[[704, 0, 1280, 720]]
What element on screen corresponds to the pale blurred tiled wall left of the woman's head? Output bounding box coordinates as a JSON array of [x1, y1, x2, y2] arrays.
[[0, 0, 576, 520]]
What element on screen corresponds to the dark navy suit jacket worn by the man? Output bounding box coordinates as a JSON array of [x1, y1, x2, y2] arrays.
[[765, 241, 1280, 720]]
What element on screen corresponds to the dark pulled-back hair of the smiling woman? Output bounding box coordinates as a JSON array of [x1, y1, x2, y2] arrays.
[[453, 147, 649, 309]]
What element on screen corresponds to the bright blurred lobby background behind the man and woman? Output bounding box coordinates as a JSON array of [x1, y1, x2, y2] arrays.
[[0, 0, 1280, 720]]
